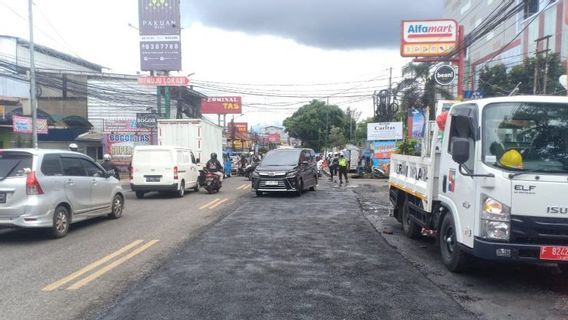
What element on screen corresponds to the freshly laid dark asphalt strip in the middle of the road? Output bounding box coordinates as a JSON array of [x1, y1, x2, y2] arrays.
[[100, 179, 475, 320]]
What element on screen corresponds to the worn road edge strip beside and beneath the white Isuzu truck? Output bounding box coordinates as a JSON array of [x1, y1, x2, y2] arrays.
[[355, 180, 568, 320]]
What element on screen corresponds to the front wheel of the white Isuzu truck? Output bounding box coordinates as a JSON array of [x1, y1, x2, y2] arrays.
[[439, 213, 471, 272]]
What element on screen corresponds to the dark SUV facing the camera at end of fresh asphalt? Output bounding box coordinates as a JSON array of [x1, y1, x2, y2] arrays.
[[252, 148, 318, 196]]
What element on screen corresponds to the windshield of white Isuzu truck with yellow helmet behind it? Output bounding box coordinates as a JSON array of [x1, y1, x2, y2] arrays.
[[482, 102, 568, 173]]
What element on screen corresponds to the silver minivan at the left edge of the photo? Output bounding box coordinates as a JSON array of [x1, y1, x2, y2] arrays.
[[0, 149, 124, 238]]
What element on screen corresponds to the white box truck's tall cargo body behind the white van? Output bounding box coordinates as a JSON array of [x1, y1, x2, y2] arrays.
[[158, 118, 223, 168]]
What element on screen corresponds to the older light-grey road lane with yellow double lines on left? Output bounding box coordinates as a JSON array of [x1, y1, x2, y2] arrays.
[[0, 178, 250, 320]]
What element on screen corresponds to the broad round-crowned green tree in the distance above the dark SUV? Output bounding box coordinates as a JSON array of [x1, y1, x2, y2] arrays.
[[284, 100, 348, 151]]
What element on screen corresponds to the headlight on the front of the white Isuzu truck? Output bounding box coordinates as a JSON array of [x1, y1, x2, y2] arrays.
[[480, 195, 511, 241]]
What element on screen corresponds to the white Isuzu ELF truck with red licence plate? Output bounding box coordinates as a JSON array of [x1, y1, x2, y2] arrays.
[[389, 96, 568, 272]]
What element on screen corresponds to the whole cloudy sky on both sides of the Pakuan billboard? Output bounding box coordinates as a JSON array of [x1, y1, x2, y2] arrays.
[[0, 0, 443, 124]]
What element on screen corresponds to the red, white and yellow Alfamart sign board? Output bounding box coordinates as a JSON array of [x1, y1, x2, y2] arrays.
[[400, 19, 458, 57]]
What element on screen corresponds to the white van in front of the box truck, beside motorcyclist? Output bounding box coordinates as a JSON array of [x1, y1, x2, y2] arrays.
[[130, 146, 199, 199]]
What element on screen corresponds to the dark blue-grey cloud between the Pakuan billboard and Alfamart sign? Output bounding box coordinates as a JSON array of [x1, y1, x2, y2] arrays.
[[182, 0, 443, 49]]
